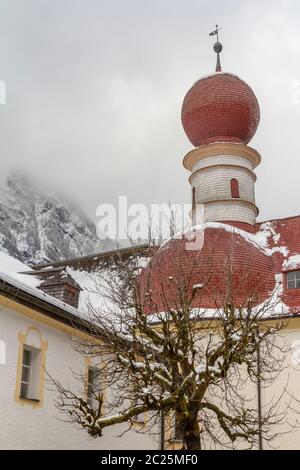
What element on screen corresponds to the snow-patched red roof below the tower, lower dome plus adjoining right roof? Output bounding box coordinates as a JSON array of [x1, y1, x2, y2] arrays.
[[140, 216, 300, 313]]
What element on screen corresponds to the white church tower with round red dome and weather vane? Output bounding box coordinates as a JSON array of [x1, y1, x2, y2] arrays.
[[181, 27, 261, 231]]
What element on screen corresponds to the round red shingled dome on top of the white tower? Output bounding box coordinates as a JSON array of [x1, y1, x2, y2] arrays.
[[181, 72, 260, 147]]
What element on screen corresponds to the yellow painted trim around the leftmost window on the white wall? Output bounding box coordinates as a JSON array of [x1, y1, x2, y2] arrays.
[[14, 326, 48, 408]]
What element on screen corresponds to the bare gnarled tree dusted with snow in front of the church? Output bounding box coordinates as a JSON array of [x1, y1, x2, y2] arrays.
[[55, 232, 286, 450]]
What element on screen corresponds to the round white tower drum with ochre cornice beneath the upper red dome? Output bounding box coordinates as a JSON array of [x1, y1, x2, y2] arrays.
[[184, 143, 260, 225]]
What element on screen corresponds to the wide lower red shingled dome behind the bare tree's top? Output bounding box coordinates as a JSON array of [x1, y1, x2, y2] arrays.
[[139, 225, 275, 313]]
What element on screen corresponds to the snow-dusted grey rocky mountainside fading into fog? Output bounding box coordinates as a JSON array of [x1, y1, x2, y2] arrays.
[[0, 176, 115, 264]]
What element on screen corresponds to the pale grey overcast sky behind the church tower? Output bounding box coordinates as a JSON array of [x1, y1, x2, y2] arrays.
[[0, 0, 300, 224]]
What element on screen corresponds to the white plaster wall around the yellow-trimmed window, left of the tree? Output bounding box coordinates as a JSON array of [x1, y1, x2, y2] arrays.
[[0, 307, 159, 450]]
